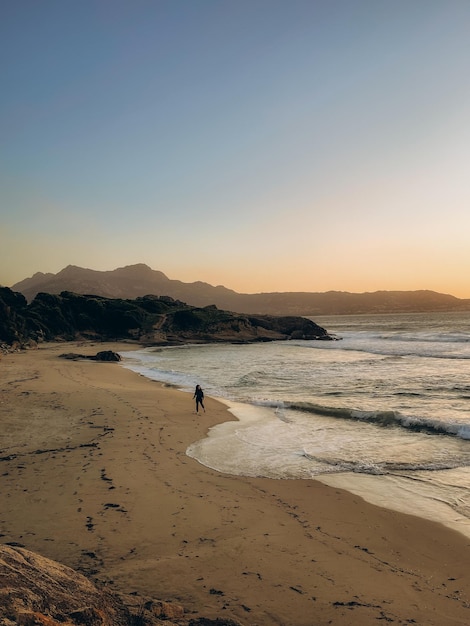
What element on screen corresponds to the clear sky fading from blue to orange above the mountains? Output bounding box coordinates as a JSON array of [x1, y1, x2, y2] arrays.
[[0, 0, 470, 298]]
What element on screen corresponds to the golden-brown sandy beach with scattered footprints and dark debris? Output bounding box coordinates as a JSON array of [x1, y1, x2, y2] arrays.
[[0, 344, 470, 626]]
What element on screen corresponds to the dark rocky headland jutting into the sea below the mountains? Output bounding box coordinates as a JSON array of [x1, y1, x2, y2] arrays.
[[0, 288, 329, 346]]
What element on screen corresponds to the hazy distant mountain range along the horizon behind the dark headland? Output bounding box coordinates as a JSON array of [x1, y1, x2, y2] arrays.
[[11, 263, 470, 316]]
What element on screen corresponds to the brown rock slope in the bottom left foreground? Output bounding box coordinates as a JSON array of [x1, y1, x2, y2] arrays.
[[0, 545, 239, 626]]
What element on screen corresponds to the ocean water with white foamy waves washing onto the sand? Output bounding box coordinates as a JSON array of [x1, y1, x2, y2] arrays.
[[122, 312, 470, 537]]
